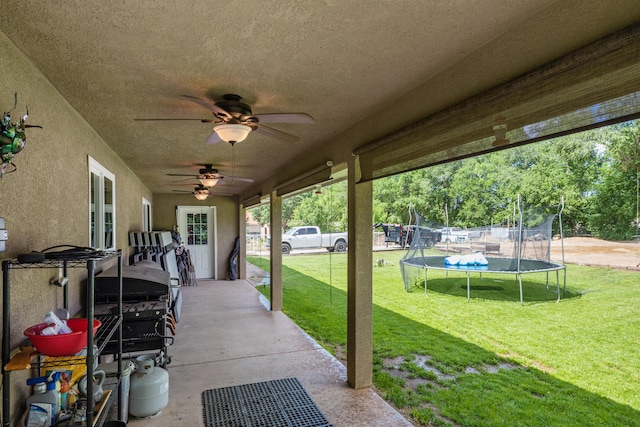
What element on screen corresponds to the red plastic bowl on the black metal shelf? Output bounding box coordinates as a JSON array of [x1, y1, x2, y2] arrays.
[[24, 318, 102, 356]]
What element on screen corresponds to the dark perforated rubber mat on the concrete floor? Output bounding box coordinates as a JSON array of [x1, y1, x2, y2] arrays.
[[202, 378, 333, 427]]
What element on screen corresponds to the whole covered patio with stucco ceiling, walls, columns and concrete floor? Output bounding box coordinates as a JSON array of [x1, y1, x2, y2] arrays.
[[0, 0, 640, 427]]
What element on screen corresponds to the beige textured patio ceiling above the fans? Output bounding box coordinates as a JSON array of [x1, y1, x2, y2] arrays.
[[0, 0, 640, 196]]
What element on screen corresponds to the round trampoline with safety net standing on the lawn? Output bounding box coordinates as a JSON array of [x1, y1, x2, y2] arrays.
[[400, 197, 567, 304]]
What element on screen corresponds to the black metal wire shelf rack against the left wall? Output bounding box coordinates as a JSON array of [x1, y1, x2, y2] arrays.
[[2, 250, 123, 427]]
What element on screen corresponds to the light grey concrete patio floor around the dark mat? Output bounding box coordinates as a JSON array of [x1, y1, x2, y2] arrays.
[[128, 279, 412, 427]]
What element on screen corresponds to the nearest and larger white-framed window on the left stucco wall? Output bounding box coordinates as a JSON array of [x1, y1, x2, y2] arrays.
[[89, 157, 116, 250]]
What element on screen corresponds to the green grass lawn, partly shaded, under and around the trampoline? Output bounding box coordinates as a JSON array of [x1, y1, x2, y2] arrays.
[[248, 251, 640, 426]]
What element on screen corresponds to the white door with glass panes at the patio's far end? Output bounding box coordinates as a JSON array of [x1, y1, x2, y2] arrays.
[[177, 206, 218, 279]]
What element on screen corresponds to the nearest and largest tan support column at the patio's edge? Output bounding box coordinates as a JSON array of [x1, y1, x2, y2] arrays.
[[347, 158, 373, 389]]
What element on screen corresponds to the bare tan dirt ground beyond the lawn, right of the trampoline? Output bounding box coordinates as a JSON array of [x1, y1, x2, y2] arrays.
[[551, 237, 640, 271]]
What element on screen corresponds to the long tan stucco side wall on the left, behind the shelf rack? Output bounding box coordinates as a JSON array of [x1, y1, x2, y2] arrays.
[[0, 32, 153, 422]]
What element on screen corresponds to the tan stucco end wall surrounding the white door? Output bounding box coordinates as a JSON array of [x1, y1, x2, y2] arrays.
[[153, 194, 239, 280]]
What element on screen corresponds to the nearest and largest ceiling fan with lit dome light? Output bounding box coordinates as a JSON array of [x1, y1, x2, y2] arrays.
[[135, 94, 314, 145]]
